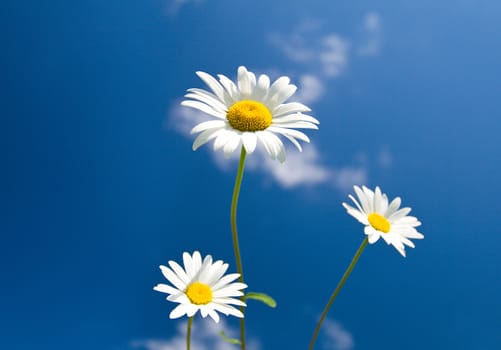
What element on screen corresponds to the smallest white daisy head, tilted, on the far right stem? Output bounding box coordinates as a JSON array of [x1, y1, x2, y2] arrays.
[[343, 186, 424, 257]]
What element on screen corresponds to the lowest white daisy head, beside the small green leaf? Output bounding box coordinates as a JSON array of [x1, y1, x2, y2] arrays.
[[153, 251, 247, 322]]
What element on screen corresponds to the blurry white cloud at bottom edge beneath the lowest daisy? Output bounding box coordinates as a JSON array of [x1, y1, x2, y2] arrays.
[[130, 319, 261, 350]]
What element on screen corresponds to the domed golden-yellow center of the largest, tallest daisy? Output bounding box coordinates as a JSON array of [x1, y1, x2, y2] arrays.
[[226, 100, 272, 131]]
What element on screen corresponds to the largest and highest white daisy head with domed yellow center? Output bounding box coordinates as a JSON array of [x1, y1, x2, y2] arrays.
[[181, 66, 319, 163]]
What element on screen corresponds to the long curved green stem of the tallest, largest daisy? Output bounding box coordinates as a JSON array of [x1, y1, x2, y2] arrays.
[[230, 146, 247, 350]]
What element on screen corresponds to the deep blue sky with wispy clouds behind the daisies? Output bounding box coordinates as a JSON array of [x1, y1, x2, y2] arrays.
[[0, 0, 501, 350]]
